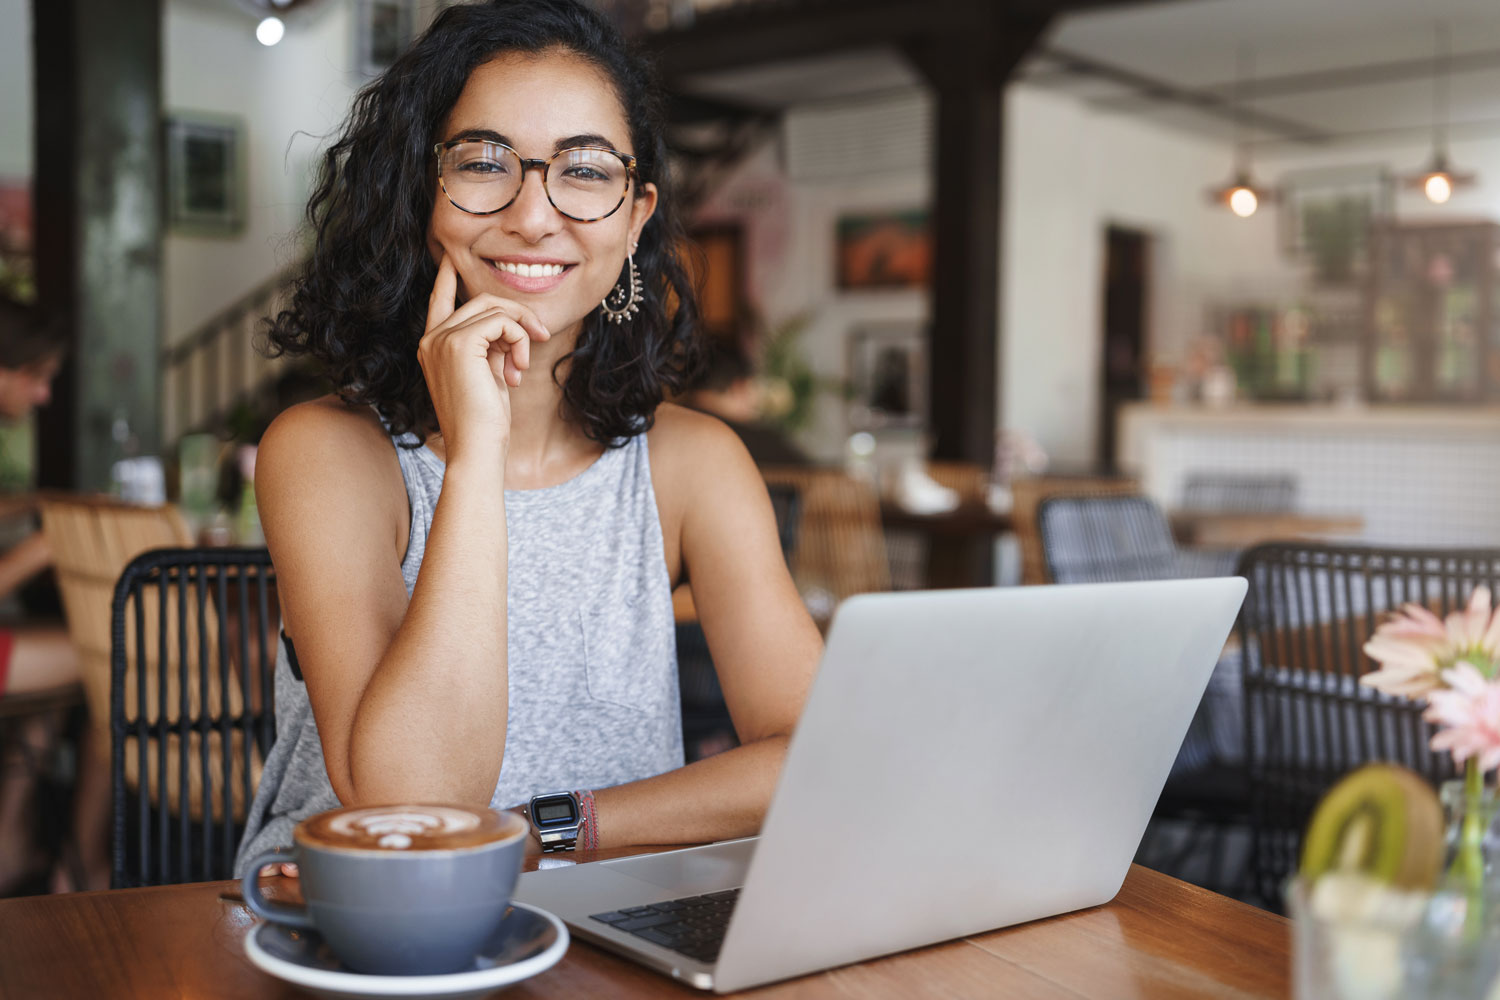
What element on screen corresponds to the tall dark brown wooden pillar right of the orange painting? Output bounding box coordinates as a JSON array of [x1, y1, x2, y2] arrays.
[[908, 14, 1047, 466]]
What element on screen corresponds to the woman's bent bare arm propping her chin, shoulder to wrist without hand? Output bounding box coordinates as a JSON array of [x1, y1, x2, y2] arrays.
[[255, 400, 507, 805]]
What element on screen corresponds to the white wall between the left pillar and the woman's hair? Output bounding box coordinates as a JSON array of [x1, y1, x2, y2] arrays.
[[165, 0, 359, 343]]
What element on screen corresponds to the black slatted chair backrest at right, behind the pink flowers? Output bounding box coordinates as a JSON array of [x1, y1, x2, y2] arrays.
[[1239, 543, 1500, 900]]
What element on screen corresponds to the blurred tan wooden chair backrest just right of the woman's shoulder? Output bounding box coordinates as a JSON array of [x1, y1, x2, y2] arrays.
[[761, 466, 891, 600]]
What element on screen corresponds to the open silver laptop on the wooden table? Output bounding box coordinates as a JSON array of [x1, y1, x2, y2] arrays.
[[516, 577, 1245, 993]]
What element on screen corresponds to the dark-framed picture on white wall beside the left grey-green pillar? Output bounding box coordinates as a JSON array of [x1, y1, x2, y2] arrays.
[[167, 112, 246, 235]]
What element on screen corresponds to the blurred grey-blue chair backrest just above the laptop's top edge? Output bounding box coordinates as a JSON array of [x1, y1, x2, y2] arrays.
[[1037, 496, 1184, 583]]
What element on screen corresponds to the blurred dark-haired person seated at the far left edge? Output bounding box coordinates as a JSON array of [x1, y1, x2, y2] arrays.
[[0, 298, 110, 895]]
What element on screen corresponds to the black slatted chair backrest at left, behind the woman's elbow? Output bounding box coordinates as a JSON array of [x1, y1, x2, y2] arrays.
[[110, 549, 279, 888]]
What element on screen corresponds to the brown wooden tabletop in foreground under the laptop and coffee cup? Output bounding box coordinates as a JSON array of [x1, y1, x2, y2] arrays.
[[0, 850, 1290, 1000]]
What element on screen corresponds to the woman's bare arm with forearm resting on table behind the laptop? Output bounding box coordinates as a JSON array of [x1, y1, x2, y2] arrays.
[[594, 408, 822, 847]]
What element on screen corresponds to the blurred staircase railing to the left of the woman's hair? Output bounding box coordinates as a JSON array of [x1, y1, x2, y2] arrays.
[[162, 262, 302, 445]]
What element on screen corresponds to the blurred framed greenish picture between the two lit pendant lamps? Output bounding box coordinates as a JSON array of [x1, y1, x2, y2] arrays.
[[1277, 165, 1395, 283]]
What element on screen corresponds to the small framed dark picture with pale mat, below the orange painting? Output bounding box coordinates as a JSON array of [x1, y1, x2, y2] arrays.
[[849, 324, 927, 430]]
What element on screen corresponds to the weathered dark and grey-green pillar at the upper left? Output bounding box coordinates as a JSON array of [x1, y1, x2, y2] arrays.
[[32, 0, 164, 490]]
